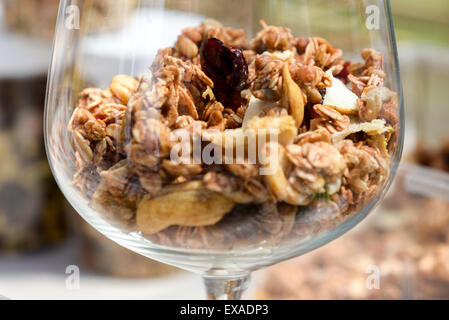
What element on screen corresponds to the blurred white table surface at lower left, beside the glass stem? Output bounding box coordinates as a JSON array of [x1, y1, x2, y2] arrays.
[[0, 241, 205, 300]]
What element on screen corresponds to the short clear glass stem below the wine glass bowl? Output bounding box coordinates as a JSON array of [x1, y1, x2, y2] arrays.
[[203, 273, 251, 300]]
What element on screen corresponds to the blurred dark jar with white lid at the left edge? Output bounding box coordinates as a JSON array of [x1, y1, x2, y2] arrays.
[[0, 31, 65, 252]]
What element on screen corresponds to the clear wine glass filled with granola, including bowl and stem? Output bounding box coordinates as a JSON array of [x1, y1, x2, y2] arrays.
[[45, 0, 404, 299]]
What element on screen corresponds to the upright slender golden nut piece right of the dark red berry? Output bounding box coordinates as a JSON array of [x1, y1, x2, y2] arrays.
[[281, 63, 306, 128]]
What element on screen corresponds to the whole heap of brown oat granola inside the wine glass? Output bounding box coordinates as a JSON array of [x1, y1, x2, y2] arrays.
[[69, 21, 399, 248]]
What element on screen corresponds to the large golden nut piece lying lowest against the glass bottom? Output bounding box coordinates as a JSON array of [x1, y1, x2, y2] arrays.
[[137, 190, 235, 234]]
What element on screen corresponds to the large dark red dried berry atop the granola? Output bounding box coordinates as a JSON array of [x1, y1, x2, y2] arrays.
[[201, 38, 248, 111]]
